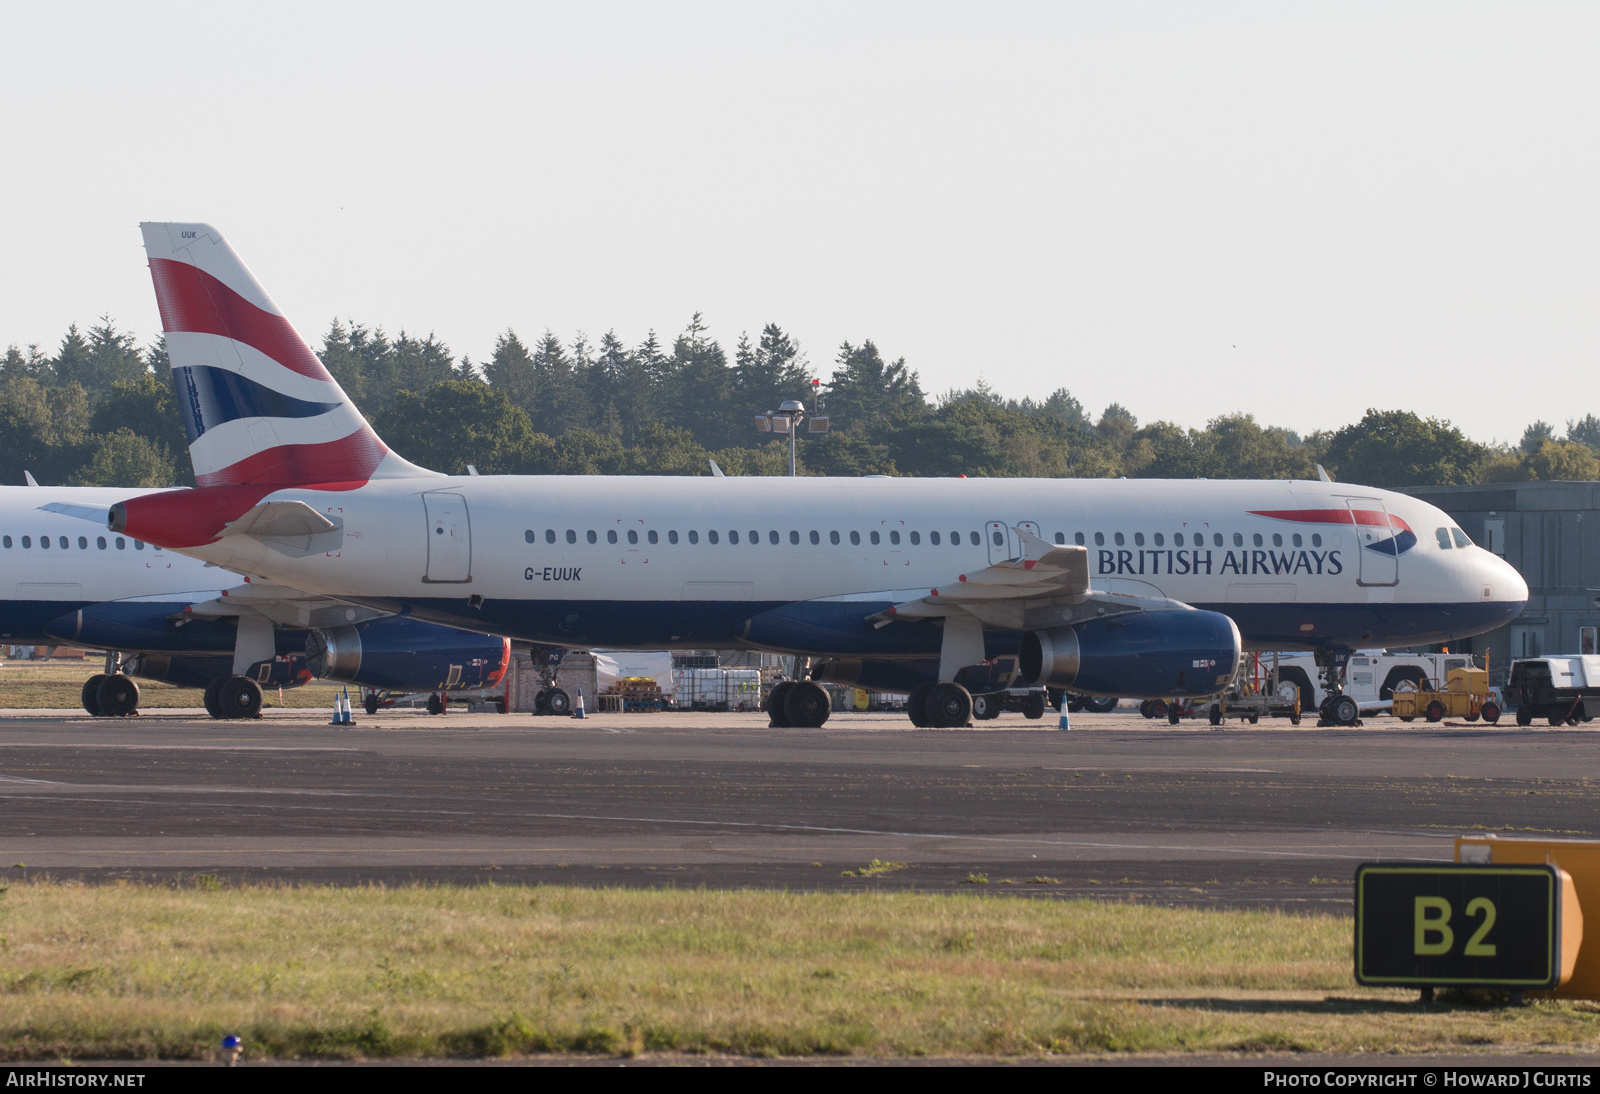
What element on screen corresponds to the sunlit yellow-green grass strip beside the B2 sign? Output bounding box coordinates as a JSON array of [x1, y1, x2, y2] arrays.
[[0, 876, 1600, 1060]]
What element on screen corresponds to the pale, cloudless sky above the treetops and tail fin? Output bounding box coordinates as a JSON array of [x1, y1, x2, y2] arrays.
[[0, 2, 1600, 440]]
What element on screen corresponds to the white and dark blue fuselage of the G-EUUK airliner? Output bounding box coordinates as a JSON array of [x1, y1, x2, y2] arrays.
[[159, 477, 1526, 648]]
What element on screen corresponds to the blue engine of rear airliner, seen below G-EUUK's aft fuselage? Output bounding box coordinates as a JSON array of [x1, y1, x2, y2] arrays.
[[306, 617, 510, 691]]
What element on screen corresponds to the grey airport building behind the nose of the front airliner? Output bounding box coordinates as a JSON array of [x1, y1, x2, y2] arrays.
[[1402, 481, 1600, 683]]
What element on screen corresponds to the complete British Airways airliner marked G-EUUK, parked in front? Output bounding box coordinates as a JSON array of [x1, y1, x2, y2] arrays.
[[84, 224, 1528, 726]]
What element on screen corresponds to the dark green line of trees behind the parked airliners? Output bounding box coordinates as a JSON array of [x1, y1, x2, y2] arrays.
[[0, 313, 1600, 488]]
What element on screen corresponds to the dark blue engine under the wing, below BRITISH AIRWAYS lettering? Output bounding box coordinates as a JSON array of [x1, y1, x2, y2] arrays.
[[1021, 611, 1242, 699]]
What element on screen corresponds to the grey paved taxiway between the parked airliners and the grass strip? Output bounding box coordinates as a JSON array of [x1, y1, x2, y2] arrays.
[[0, 712, 1600, 910]]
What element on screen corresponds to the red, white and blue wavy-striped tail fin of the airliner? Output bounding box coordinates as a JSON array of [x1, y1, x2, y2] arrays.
[[139, 224, 432, 489]]
